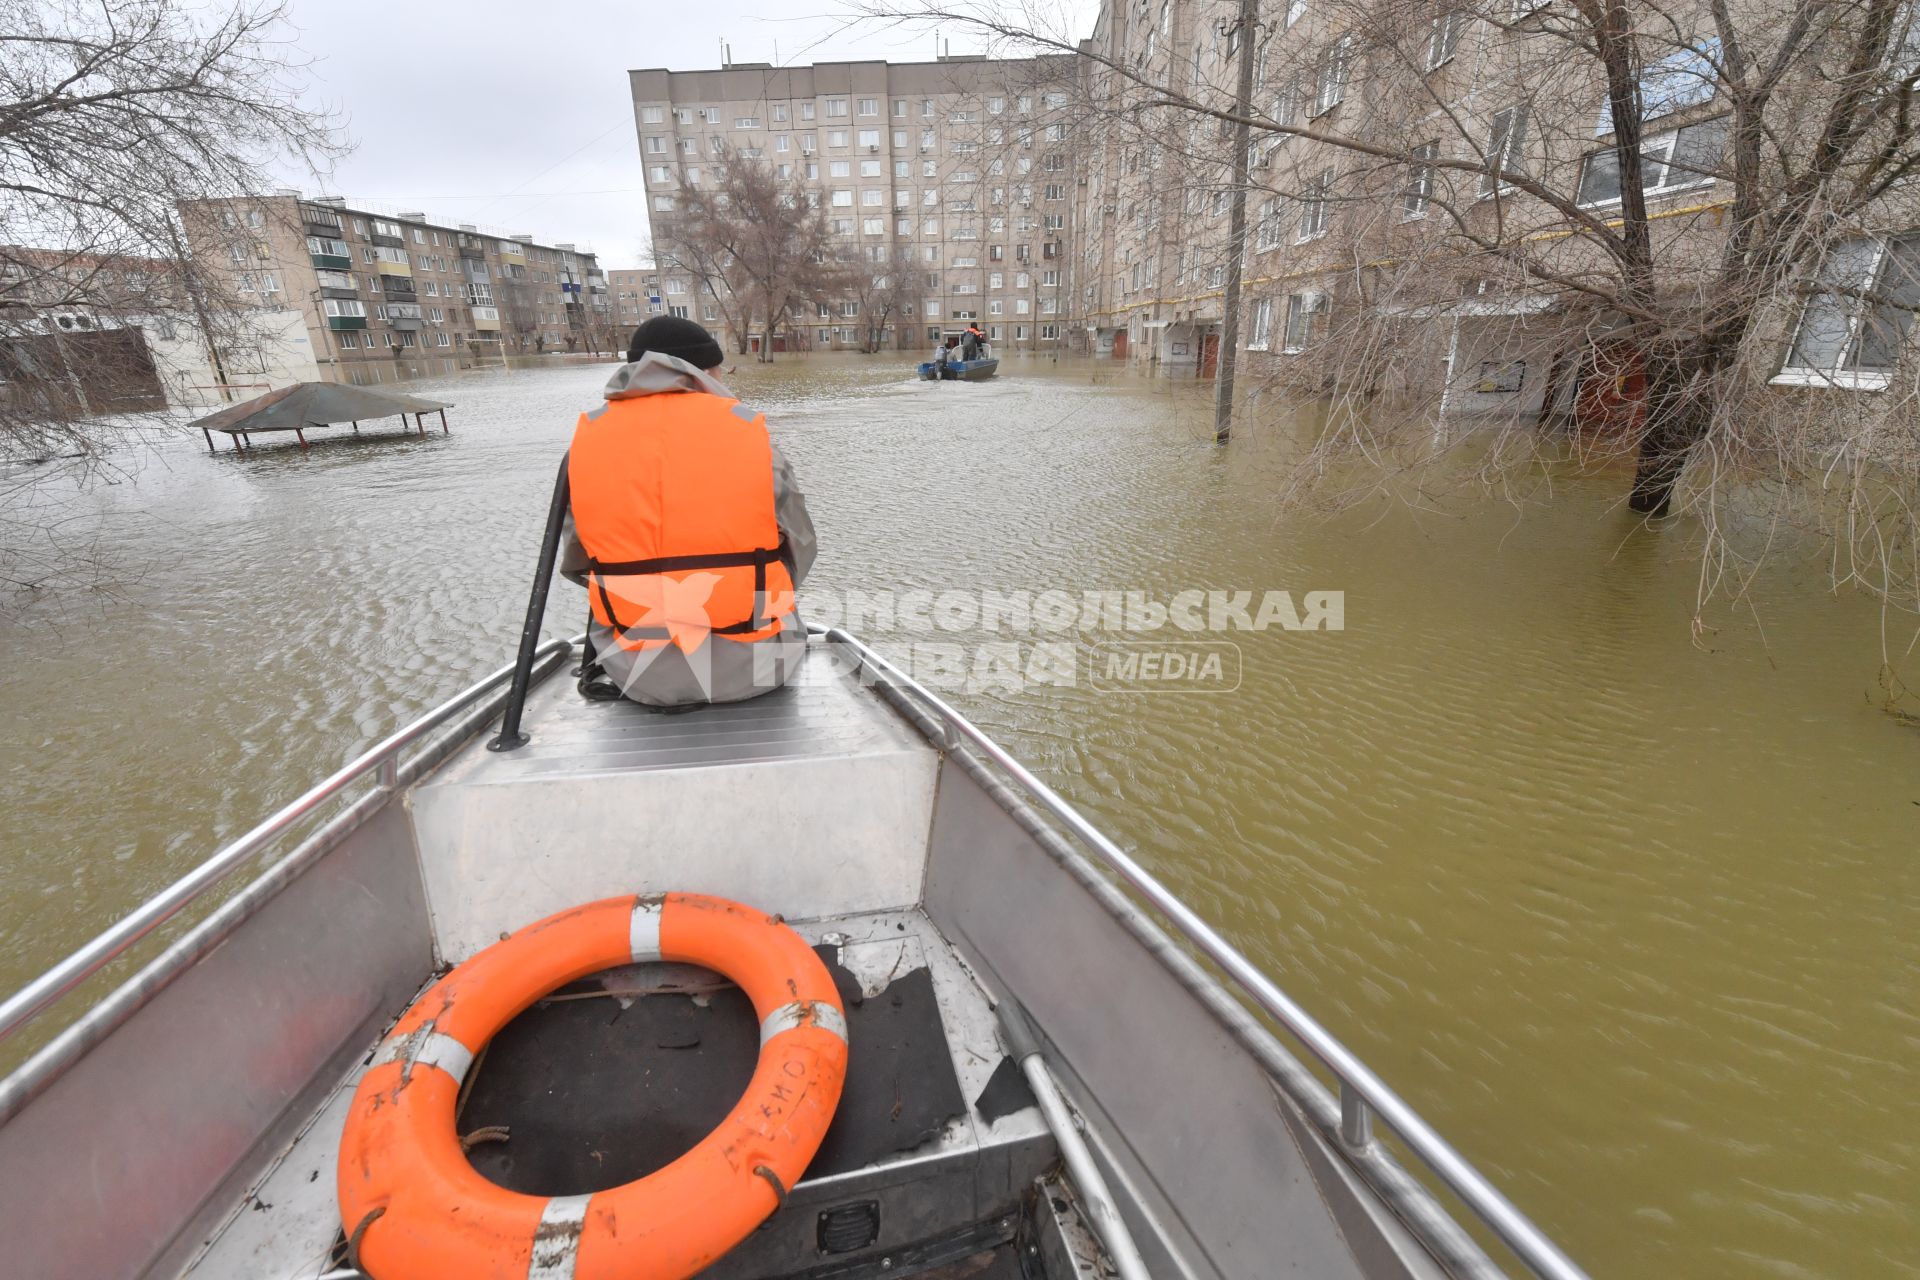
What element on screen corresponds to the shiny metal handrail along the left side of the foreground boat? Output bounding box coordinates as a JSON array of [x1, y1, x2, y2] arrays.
[[0, 637, 580, 1042]]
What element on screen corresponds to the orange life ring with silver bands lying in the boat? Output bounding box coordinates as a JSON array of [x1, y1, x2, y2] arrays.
[[338, 894, 847, 1280]]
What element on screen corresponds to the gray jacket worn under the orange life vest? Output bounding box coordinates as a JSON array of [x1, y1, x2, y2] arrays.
[[561, 351, 818, 706]]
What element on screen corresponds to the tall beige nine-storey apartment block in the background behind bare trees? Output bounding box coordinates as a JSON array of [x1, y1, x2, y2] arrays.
[[628, 58, 1083, 351]]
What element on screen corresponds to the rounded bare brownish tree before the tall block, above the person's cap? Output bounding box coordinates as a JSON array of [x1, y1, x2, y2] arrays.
[[662, 154, 835, 361]]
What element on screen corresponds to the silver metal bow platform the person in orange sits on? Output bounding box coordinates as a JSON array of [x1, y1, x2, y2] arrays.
[[409, 645, 939, 963]]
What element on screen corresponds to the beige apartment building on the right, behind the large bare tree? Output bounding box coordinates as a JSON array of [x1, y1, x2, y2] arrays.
[[1071, 0, 1920, 435]]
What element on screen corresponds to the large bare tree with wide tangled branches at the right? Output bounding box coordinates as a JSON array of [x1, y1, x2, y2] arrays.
[[864, 0, 1920, 610]]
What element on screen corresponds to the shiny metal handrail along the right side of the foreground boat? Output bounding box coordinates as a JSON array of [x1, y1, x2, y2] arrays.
[[808, 628, 1588, 1280]]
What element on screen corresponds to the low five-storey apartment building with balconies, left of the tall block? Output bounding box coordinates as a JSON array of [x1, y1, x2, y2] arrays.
[[180, 192, 612, 365]]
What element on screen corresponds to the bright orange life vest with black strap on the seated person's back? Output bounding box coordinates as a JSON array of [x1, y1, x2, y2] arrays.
[[566, 391, 793, 652]]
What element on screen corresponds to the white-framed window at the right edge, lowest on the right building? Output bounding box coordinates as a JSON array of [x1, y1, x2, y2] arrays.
[[1774, 232, 1920, 391]]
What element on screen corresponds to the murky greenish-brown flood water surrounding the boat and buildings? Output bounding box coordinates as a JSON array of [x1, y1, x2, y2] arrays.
[[0, 357, 1920, 1278]]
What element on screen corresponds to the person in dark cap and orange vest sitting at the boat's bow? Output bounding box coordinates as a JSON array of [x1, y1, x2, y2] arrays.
[[561, 315, 816, 706]]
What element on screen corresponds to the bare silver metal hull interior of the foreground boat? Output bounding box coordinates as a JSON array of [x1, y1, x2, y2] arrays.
[[0, 639, 1578, 1280]]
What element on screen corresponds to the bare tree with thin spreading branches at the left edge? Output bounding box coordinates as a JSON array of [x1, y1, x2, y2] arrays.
[[0, 0, 340, 585]]
